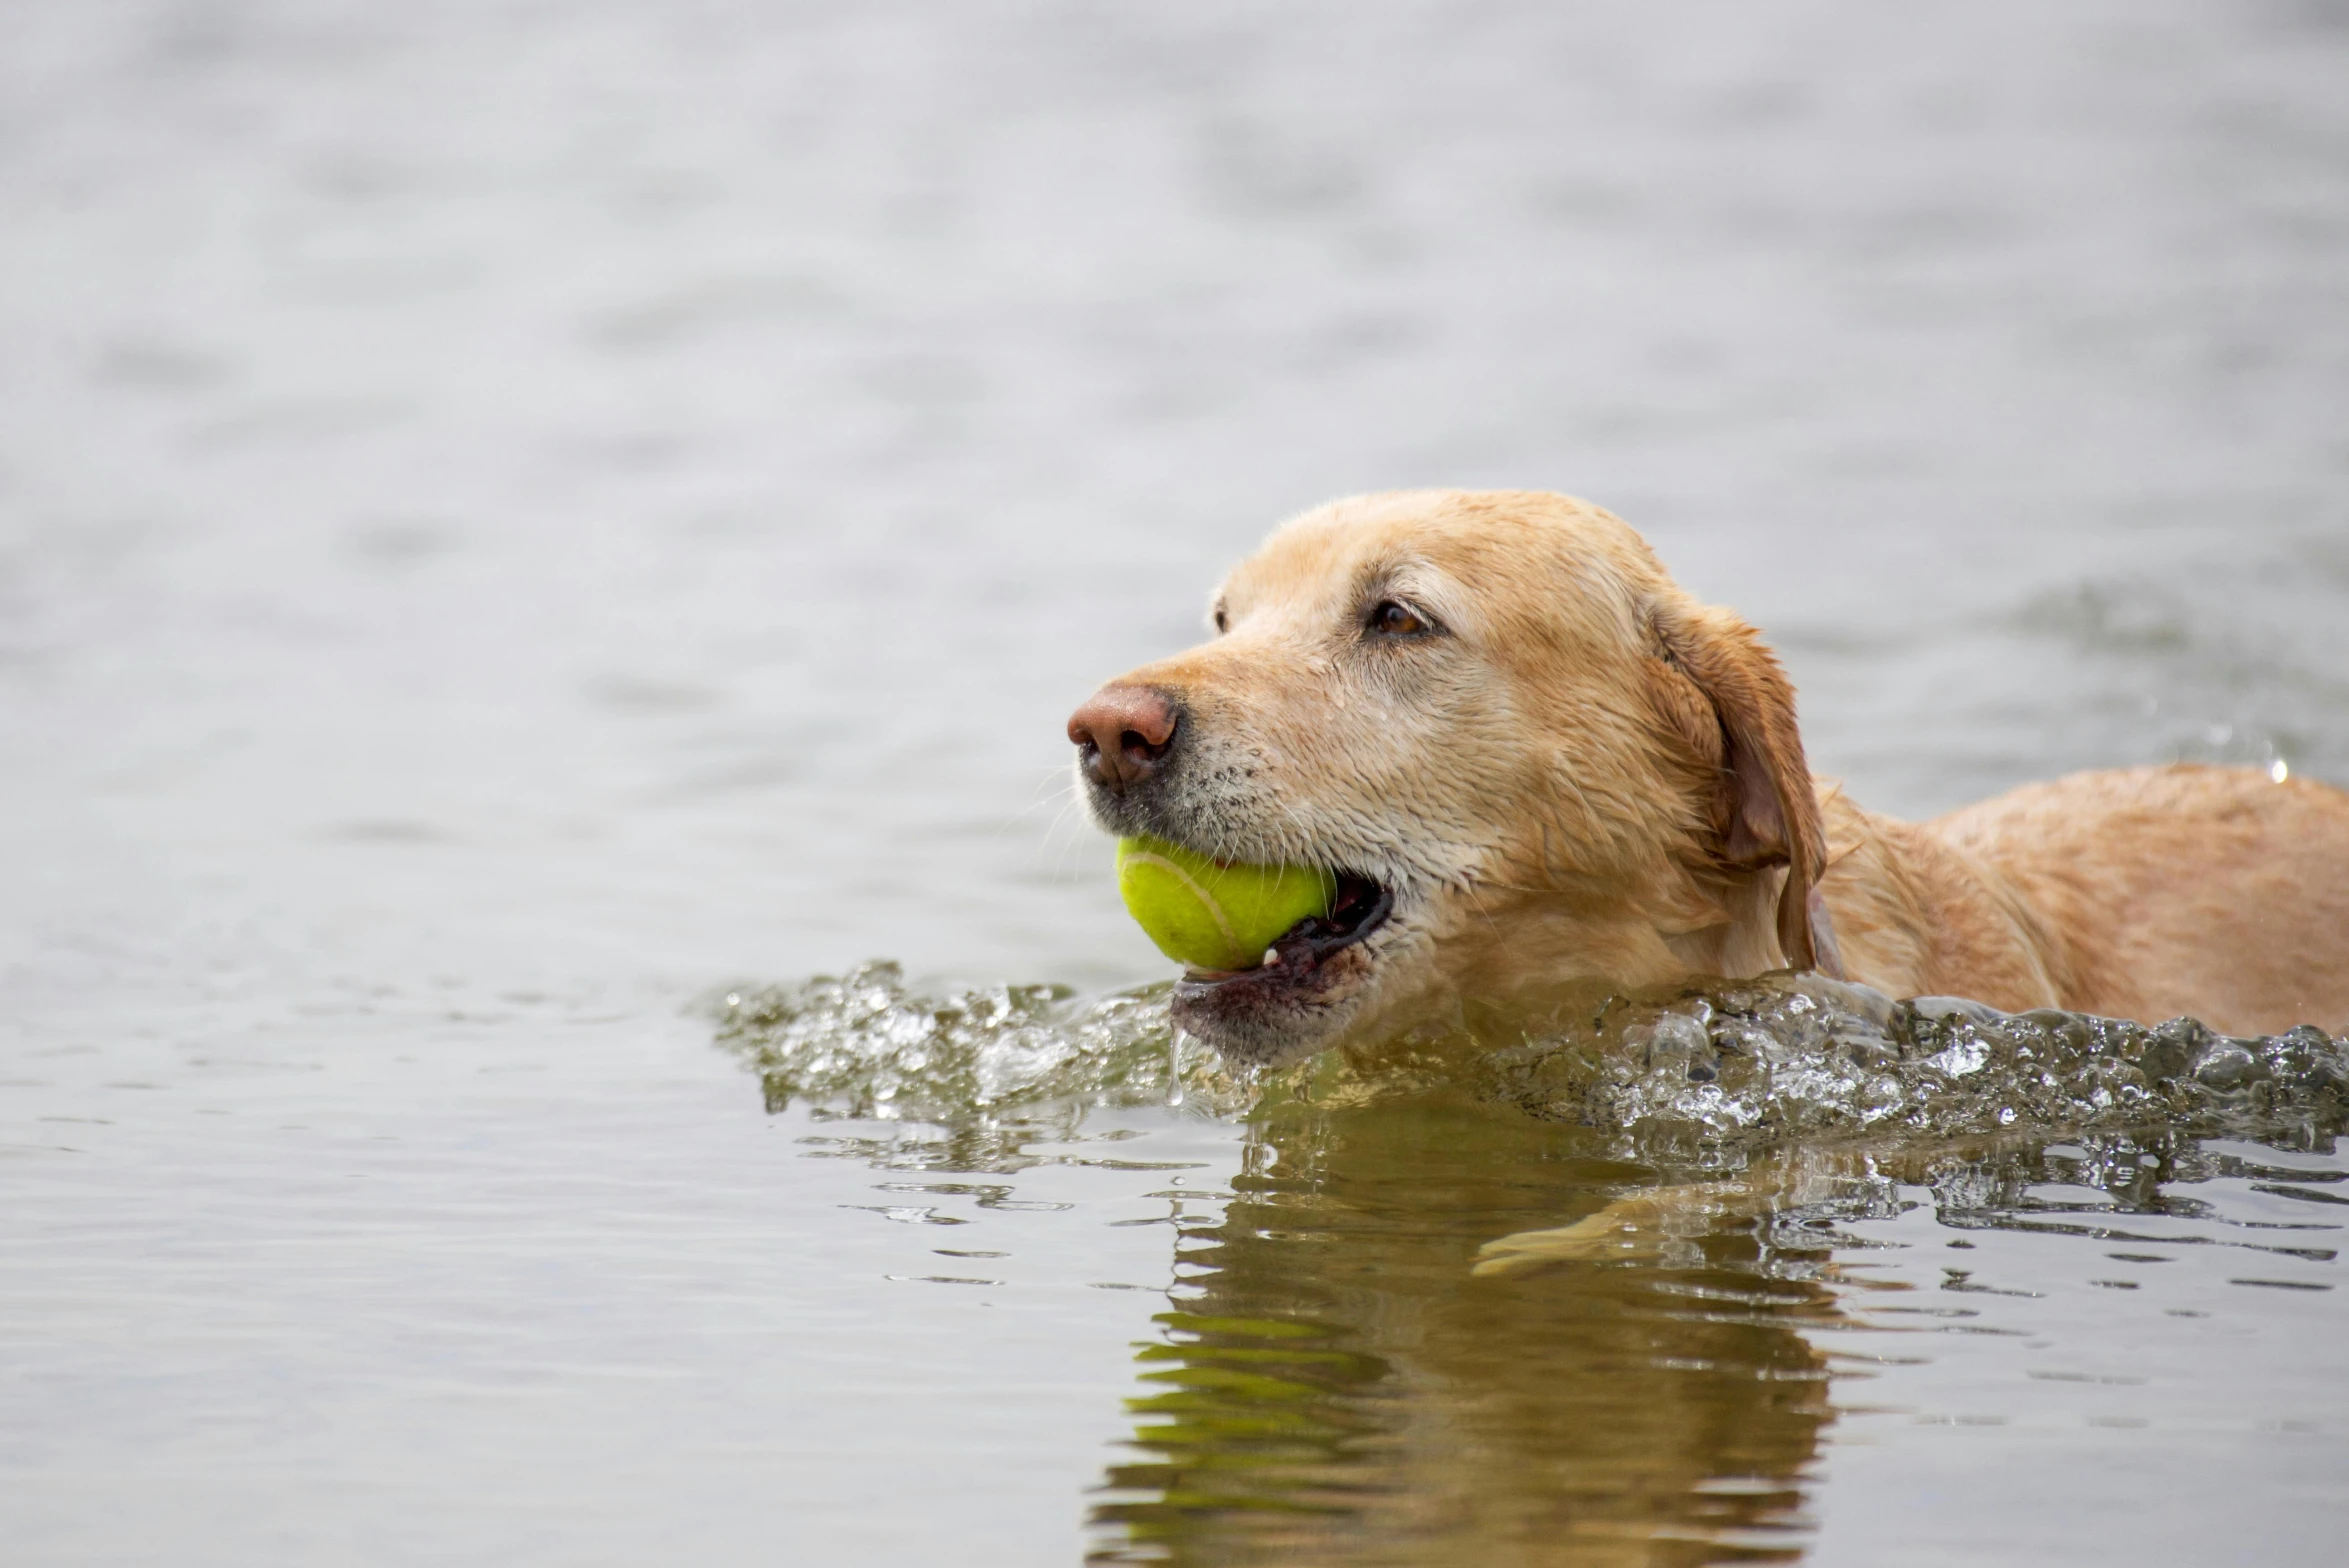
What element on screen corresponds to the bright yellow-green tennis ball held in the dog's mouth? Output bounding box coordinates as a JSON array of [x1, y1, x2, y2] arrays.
[[1118, 838, 1337, 969]]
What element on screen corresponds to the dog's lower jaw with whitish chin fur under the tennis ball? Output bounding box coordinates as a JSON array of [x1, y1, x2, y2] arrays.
[[1172, 883, 1395, 1068]]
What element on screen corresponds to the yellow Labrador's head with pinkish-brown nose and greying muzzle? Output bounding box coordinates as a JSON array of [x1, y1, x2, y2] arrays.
[[1069, 491, 1832, 1063]]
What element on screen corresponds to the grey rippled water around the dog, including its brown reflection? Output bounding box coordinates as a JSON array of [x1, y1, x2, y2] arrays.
[[0, 0, 2349, 1563]]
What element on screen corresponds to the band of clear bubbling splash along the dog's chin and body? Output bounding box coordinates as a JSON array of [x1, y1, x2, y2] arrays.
[[712, 962, 2349, 1150]]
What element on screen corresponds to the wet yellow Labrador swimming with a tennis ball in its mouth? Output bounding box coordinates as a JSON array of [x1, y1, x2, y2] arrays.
[[1069, 491, 2349, 1063]]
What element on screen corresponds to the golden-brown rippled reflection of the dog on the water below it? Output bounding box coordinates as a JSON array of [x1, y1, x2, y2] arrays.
[[1095, 1091, 1846, 1568]]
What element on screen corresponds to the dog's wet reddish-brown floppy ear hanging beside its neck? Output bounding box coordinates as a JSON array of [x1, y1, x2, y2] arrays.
[[1649, 601, 1844, 979]]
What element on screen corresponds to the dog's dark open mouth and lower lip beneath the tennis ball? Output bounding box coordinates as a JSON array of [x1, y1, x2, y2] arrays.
[[1172, 871, 1395, 1063]]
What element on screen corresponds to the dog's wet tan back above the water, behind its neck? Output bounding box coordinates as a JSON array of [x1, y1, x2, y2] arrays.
[[1926, 765, 2349, 1033]]
